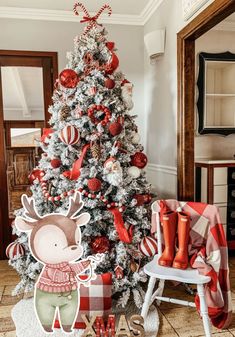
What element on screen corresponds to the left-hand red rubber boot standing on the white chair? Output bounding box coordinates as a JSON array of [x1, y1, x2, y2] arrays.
[[158, 211, 178, 267]]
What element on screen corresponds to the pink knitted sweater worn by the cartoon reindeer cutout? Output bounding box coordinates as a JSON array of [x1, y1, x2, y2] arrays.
[[37, 260, 90, 293]]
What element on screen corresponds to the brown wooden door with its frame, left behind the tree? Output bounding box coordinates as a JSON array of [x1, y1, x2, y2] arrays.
[[0, 50, 58, 259]]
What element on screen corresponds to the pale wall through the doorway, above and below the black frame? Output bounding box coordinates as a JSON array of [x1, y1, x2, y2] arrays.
[[195, 30, 235, 159]]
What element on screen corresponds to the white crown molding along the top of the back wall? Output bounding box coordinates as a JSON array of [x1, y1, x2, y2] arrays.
[[0, 0, 164, 26]]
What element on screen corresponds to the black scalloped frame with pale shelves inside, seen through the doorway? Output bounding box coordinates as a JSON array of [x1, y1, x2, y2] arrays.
[[197, 52, 235, 135]]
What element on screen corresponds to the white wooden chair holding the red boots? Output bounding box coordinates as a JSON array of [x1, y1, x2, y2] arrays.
[[141, 202, 211, 337]]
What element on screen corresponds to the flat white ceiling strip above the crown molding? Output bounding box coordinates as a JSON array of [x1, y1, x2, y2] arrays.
[[0, 0, 151, 15]]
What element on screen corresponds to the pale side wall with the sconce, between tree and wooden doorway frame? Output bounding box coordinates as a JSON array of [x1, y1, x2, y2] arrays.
[[144, 0, 212, 198]]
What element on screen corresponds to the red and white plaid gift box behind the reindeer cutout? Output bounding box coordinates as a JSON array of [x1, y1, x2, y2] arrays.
[[55, 273, 112, 329]]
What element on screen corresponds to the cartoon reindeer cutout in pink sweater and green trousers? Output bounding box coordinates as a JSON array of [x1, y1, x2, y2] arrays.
[[15, 192, 102, 333]]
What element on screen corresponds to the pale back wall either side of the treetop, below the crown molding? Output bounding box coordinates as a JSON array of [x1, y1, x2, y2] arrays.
[[0, 19, 145, 138]]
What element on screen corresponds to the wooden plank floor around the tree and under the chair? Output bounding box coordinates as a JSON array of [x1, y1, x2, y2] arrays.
[[0, 257, 235, 337]]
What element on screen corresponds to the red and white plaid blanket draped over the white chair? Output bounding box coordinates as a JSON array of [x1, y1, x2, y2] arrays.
[[152, 200, 232, 329]]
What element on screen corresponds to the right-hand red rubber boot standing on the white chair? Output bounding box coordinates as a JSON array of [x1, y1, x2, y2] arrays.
[[173, 212, 190, 269]]
